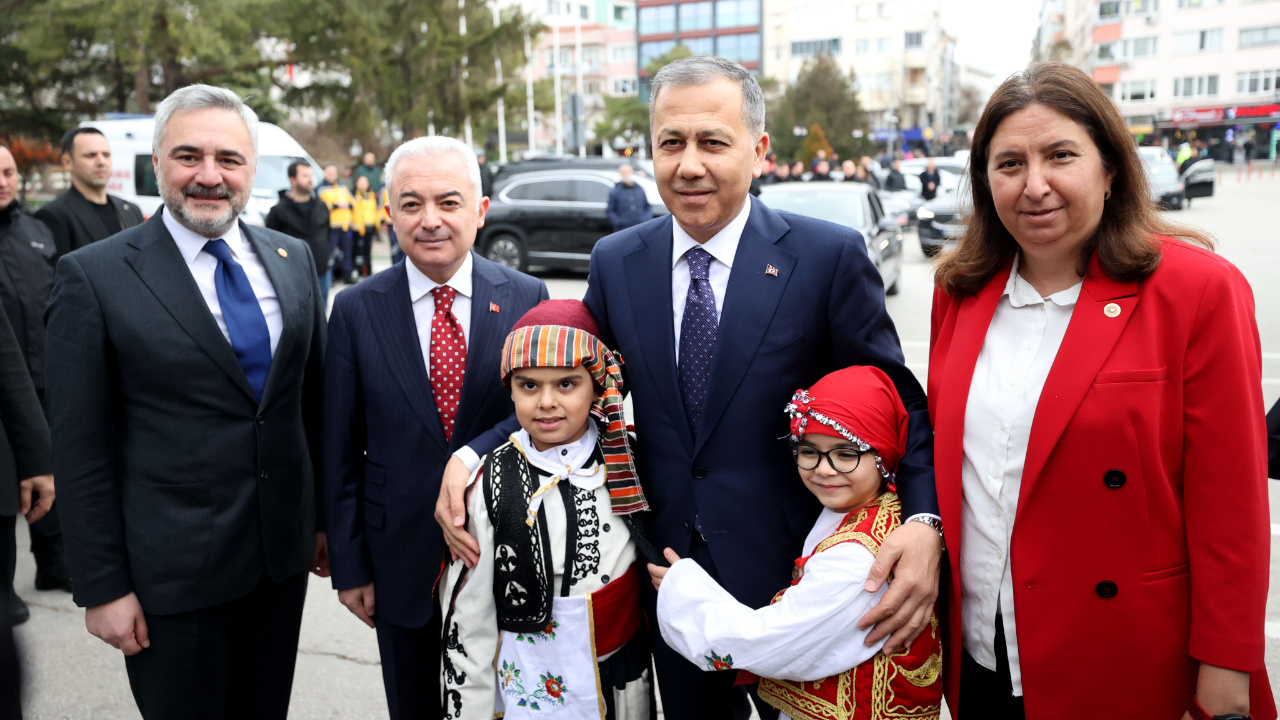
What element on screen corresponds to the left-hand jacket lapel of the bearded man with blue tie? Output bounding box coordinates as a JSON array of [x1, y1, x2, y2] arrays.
[[125, 213, 257, 405]]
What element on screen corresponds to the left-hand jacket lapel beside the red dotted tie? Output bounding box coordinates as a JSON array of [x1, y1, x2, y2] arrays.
[[365, 260, 448, 451]]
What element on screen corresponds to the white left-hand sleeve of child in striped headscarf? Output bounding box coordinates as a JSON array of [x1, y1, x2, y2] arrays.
[[438, 465, 498, 720]]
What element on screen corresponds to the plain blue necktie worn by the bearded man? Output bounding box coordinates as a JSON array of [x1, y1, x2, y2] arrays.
[[205, 240, 271, 400]]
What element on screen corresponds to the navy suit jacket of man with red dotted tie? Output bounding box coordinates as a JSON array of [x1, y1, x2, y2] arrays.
[[323, 254, 547, 628]]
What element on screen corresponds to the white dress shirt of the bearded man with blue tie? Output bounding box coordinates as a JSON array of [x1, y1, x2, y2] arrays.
[[160, 206, 284, 356]]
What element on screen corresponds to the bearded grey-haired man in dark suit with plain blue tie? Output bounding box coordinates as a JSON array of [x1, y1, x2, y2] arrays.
[[47, 85, 328, 720]]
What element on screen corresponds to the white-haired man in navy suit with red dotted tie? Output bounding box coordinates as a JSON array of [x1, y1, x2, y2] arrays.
[[324, 137, 548, 719]]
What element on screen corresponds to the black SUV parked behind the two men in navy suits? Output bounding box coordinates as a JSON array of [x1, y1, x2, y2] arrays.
[[476, 168, 667, 270]]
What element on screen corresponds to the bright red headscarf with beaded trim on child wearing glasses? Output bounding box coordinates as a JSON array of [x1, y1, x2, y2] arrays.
[[786, 365, 908, 483]]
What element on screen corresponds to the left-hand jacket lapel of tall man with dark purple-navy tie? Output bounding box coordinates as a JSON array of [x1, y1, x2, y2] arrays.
[[622, 215, 692, 438]]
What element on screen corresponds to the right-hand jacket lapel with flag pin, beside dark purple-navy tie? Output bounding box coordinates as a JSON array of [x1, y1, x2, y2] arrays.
[[696, 197, 796, 454]]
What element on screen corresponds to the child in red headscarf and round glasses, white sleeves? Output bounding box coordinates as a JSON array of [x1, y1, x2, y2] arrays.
[[649, 366, 942, 720]]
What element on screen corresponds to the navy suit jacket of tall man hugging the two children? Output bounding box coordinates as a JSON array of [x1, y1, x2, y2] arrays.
[[585, 197, 937, 607]]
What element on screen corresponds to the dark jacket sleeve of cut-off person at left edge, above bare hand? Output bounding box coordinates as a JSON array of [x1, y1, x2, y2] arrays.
[[0, 298, 54, 515]]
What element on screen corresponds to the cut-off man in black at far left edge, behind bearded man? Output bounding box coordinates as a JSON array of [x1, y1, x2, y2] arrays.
[[0, 146, 72, 592]]
